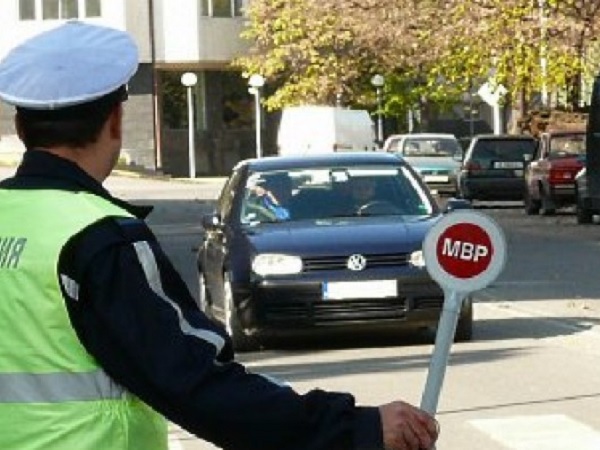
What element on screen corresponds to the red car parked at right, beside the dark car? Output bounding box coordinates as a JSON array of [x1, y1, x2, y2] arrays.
[[525, 130, 585, 215]]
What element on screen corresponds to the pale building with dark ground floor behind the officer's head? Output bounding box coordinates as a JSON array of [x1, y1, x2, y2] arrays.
[[0, 0, 273, 176]]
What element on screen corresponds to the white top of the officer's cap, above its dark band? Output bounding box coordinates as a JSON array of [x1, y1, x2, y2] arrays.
[[0, 21, 138, 110]]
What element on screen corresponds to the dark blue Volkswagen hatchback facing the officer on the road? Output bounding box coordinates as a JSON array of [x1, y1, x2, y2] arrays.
[[197, 152, 473, 351]]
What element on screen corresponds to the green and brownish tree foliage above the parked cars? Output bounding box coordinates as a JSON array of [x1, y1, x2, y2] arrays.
[[234, 0, 600, 118]]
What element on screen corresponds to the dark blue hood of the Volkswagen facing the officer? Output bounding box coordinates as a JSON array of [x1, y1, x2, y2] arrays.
[[245, 216, 439, 256]]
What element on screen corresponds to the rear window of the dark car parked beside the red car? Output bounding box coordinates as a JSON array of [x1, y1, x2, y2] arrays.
[[471, 139, 536, 168]]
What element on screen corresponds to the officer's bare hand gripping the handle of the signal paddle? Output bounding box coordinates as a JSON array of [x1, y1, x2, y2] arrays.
[[379, 401, 438, 450]]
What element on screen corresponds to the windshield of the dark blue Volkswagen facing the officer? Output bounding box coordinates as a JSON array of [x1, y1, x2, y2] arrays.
[[240, 166, 434, 225]]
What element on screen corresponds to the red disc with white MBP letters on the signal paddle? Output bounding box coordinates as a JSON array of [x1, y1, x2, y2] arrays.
[[436, 223, 494, 278]]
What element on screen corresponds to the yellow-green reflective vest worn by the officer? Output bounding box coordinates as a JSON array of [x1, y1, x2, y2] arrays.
[[0, 189, 168, 450]]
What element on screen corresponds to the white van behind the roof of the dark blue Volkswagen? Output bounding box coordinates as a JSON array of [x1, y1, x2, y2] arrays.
[[277, 105, 377, 155]]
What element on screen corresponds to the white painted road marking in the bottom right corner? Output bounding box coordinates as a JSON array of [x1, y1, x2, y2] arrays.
[[469, 414, 600, 450]]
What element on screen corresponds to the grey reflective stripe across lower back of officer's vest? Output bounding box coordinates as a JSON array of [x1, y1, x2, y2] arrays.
[[0, 370, 126, 403]]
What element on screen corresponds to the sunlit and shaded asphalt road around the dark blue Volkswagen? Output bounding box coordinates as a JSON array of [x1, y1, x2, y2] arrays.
[[0, 169, 600, 450]]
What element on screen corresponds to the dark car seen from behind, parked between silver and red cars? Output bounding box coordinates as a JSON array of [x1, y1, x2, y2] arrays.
[[458, 134, 537, 201]]
